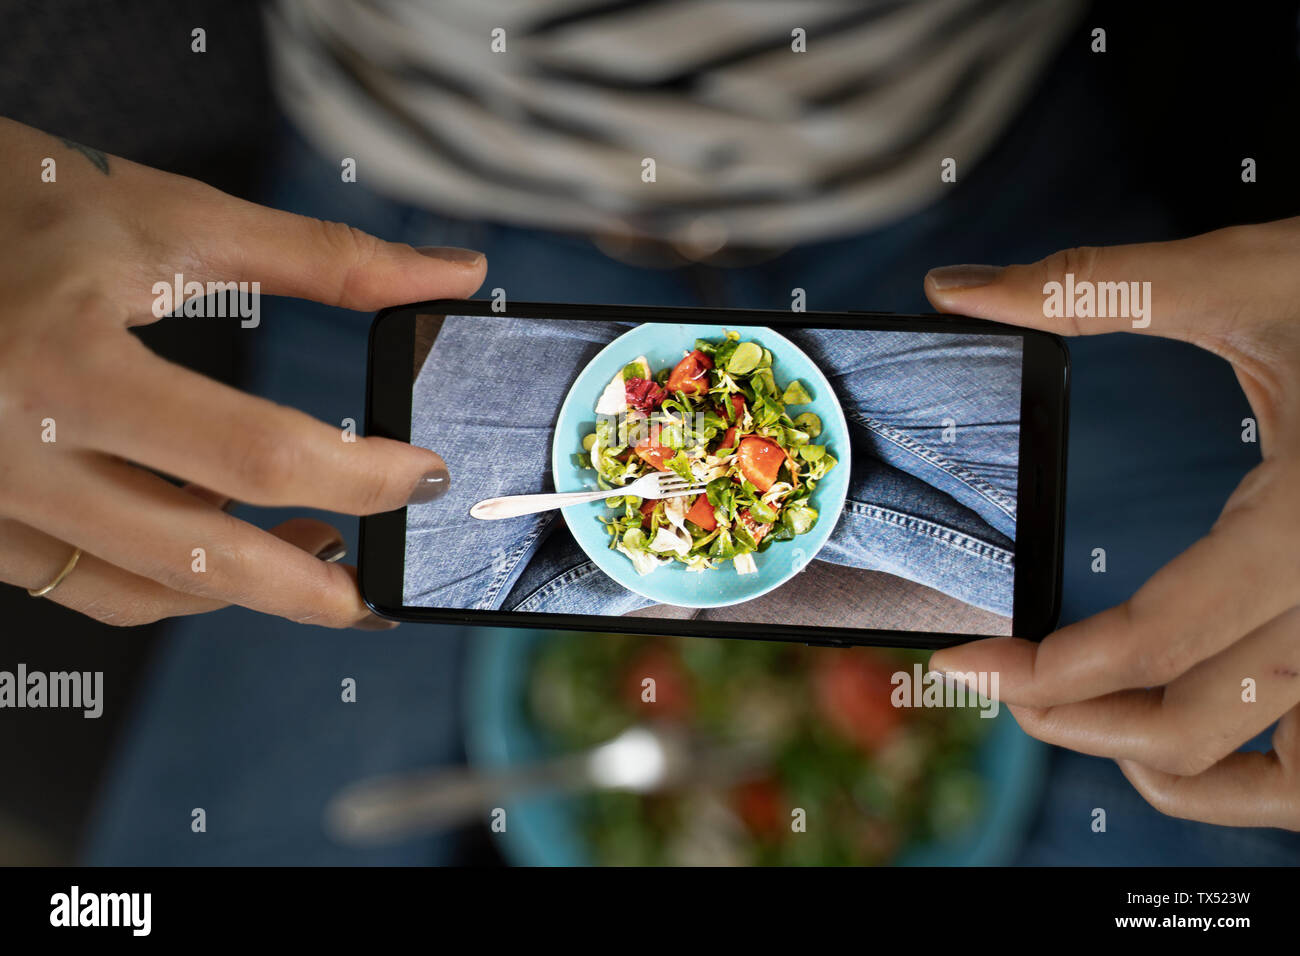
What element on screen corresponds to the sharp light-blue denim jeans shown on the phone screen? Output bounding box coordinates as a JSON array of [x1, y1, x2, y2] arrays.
[[404, 317, 1021, 617]]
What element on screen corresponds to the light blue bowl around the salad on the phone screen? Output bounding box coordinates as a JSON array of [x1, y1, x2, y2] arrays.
[[551, 323, 850, 607]]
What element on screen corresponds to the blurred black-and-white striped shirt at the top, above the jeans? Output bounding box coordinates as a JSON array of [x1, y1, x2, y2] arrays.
[[268, 0, 1080, 248]]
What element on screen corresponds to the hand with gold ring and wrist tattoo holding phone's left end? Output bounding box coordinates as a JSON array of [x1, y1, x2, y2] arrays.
[[0, 120, 486, 627]]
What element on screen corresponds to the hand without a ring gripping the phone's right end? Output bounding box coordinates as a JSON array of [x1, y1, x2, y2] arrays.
[[926, 217, 1300, 830]]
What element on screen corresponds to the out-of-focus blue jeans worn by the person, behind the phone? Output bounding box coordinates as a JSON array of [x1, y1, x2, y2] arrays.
[[86, 33, 1300, 865]]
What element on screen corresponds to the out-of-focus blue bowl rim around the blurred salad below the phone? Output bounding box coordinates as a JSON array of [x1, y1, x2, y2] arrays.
[[465, 628, 1048, 866]]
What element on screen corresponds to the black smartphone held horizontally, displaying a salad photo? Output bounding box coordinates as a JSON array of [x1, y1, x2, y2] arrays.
[[359, 300, 1069, 648]]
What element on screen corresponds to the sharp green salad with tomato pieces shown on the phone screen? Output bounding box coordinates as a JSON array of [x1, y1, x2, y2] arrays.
[[573, 332, 836, 575]]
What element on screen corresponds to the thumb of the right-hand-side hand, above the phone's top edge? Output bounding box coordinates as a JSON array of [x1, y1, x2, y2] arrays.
[[926, 229, 1251, 339]]
